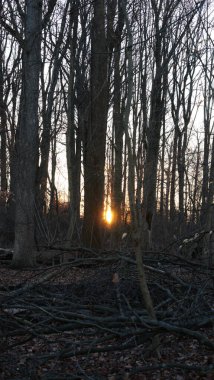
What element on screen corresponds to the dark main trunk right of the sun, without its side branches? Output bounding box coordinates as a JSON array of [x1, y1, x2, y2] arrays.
[[143, 0, 164, 250]]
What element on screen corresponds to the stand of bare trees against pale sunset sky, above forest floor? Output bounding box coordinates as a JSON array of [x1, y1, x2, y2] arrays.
[[0, 0, 214, 258]]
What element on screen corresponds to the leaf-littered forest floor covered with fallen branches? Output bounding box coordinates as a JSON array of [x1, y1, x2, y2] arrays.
[[0, 250, 214, 380]]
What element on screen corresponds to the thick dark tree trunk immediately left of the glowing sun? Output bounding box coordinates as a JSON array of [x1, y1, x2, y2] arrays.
[[83, 0, 108, 248]]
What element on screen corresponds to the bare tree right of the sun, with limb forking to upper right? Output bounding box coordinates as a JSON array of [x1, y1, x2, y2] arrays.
[[143, 0, 204, 248]]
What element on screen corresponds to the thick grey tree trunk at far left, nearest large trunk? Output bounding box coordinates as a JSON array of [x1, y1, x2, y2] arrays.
[[12, 0, 42, 267]]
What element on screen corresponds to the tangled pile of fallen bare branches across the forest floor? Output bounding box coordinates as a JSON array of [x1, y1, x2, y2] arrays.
[[0, 251, 214, 379]]
